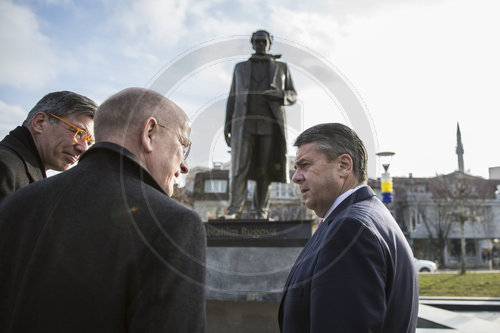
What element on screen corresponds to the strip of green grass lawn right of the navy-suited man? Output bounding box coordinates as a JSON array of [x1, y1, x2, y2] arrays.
[[418, 272, 500, 297]]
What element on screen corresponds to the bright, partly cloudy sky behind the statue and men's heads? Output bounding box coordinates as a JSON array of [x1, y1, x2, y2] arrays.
[[0, 0, 500, 178]]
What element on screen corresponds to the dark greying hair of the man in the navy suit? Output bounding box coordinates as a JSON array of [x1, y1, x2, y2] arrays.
[[294, 123, 368, 182]]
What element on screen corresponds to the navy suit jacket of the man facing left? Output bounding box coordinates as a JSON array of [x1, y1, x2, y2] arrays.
[[279, 187, 418, 333]]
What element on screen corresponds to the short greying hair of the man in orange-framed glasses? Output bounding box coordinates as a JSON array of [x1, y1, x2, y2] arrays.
[[23, 91, 97, 127]]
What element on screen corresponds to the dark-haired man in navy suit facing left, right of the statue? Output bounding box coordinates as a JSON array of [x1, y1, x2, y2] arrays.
[[278, 123, 418, 333]]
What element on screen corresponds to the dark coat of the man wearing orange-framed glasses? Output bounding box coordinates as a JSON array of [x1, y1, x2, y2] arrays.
[[0, 126, 46, 200]]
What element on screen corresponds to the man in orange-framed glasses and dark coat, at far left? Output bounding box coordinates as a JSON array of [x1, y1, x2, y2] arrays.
[[0, 91, 97, 200]]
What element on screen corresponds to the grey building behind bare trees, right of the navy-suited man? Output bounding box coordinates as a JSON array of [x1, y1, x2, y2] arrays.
[[369, 171, 500, 266]]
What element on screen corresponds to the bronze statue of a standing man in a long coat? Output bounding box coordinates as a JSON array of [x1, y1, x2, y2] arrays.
[[224, 30, 297, 219]]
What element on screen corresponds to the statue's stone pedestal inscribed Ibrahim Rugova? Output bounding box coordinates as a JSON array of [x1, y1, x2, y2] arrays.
[[205, 220, 312, 333]]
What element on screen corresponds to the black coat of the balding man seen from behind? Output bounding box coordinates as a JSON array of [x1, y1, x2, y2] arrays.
[[0, 142, 206, 333]]
